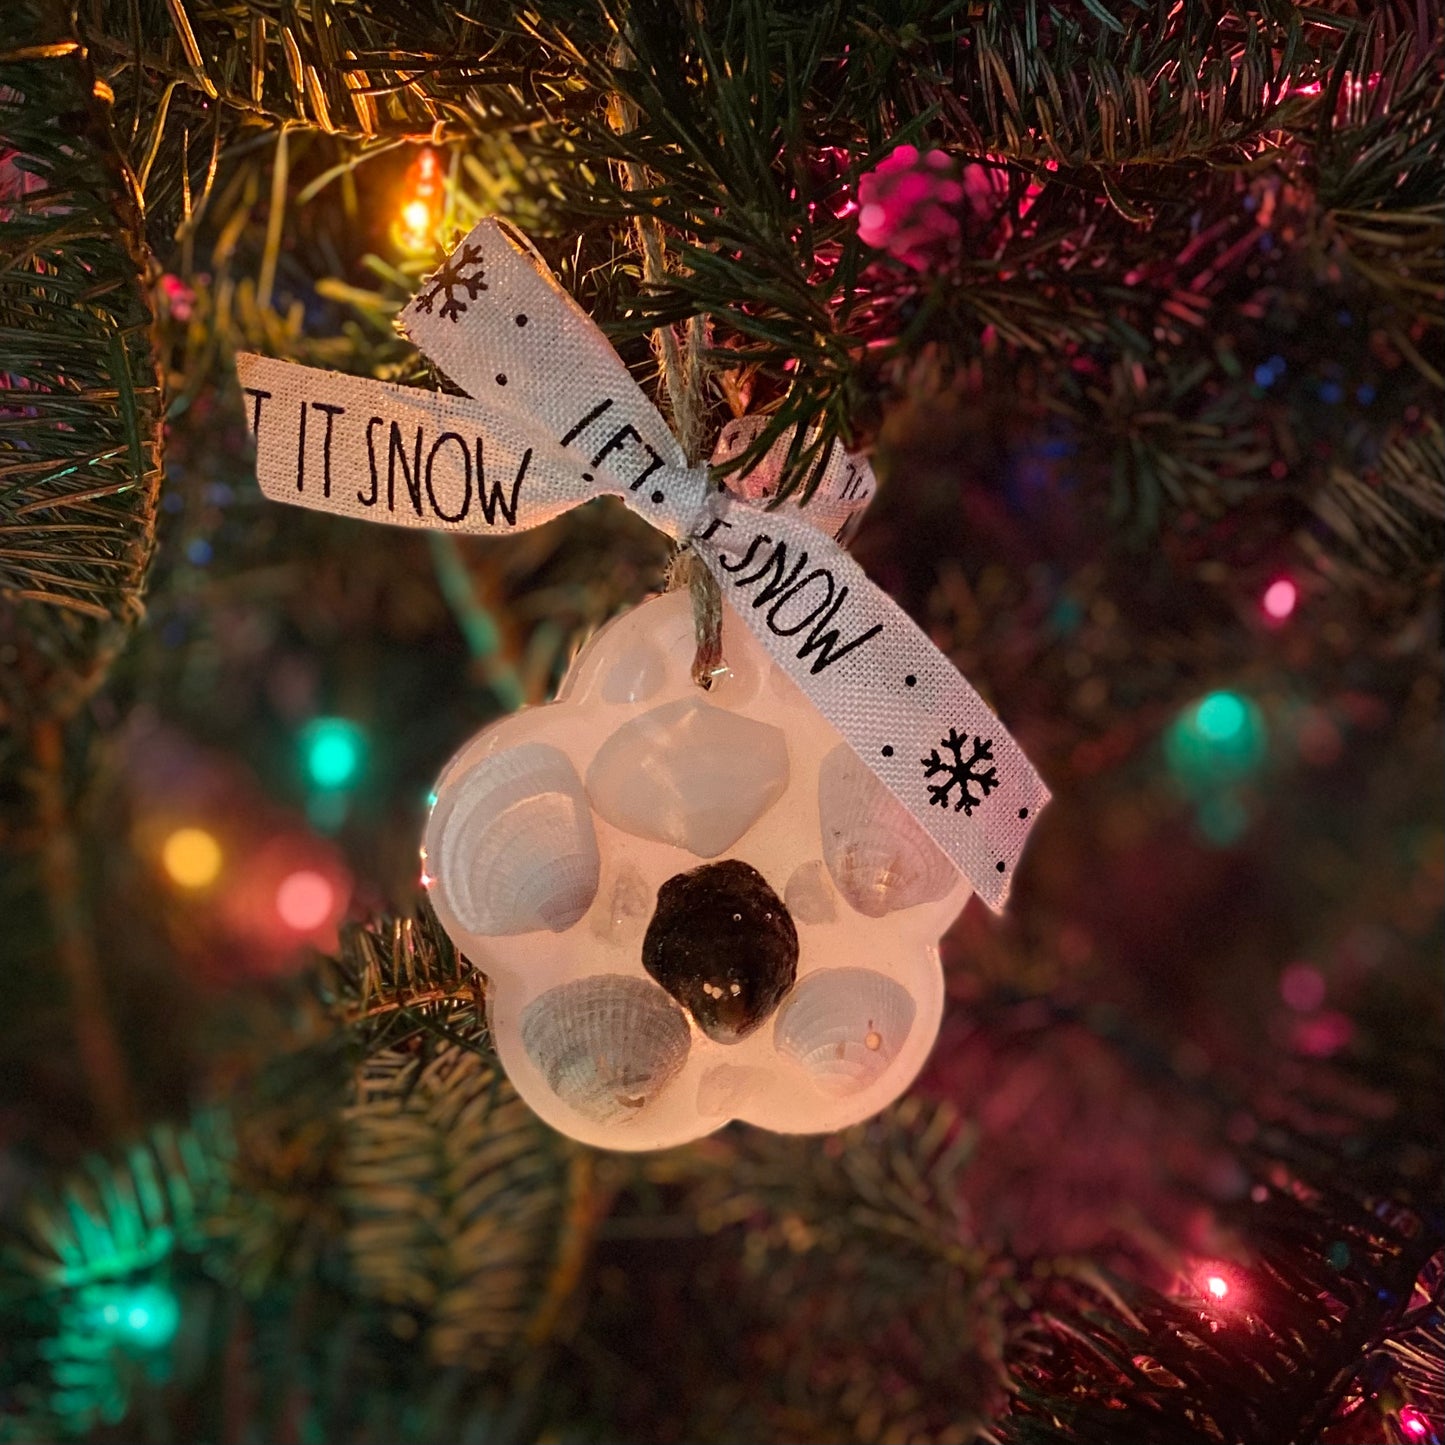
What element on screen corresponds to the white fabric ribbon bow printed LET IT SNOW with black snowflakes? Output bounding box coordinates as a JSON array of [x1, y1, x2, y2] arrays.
[[237, 221, 1049, 909]]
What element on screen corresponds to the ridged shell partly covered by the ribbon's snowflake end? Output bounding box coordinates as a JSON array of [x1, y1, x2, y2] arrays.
[[818, 743, 958, 918]]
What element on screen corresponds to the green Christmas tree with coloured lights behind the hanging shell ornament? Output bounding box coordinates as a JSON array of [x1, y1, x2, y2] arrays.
[[0, 0, 1445, 1445]]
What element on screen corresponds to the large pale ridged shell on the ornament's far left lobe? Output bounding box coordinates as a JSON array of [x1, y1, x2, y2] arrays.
[[428, 743, 598, 938]]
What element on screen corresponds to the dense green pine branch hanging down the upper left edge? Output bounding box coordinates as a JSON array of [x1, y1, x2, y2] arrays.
[[0, 0, 162, 733]]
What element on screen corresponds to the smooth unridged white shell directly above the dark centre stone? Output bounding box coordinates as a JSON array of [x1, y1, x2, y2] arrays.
[[587, 698, 788, 858]]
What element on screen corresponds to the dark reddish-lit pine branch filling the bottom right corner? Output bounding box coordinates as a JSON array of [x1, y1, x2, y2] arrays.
[[1003, 1038, 1445, 1445]]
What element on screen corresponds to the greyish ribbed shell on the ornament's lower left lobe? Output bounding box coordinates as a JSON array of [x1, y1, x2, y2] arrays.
[[522, 974, 689, 1124]]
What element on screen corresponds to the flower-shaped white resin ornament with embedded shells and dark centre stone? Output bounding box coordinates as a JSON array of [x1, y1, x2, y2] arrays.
[[422, 591, 970, 1149]]
